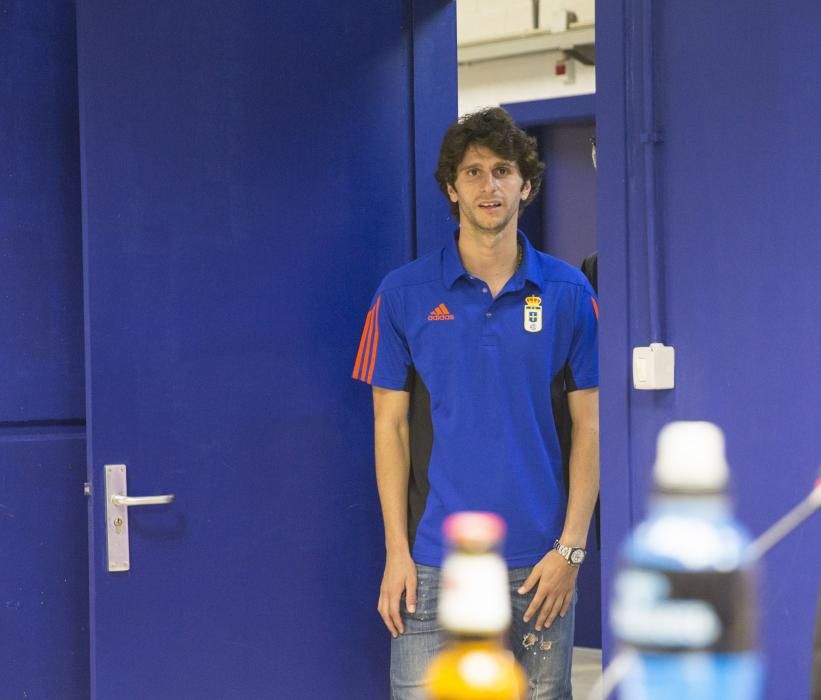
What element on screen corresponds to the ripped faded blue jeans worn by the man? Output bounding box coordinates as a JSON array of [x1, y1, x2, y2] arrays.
[[391, 564, 576, 700]]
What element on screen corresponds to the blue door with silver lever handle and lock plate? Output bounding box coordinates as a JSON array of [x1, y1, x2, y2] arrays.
[[78, 0, 456, 700]]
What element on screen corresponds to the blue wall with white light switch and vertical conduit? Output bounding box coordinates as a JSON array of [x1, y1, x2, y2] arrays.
[[597, 0, 821, 699]]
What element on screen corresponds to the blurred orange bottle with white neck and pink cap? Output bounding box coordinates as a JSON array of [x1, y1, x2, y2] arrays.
[[425, 512, 527, 700]]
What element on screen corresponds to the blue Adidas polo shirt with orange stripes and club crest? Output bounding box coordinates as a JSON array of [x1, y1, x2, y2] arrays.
[[353, 233, 598, 567]]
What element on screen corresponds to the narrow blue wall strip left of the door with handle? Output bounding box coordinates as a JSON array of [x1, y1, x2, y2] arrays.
[[0, 0, 89, 699]]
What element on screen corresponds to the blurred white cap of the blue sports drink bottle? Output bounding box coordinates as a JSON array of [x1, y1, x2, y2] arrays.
[[653, 421, 730, 492]]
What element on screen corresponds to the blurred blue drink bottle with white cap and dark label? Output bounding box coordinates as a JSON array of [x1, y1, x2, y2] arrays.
[[611, 422, 763, 700]]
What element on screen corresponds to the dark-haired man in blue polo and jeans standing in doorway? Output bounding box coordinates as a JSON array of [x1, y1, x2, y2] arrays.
[[354, 108, 599, 700]]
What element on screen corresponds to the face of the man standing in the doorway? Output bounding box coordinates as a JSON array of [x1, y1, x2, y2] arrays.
[[448, 146, 530, 233]]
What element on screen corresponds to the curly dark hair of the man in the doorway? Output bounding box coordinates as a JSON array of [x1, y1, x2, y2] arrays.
[[436, 107, 544, 221]]
